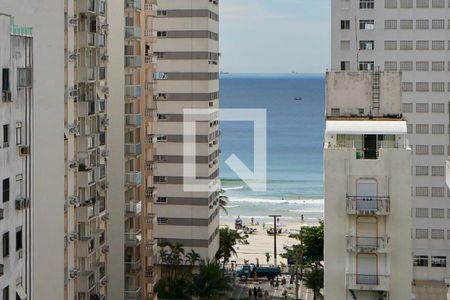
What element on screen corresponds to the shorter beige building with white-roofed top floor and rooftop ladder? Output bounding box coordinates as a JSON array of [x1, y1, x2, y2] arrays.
[[324, 71, 412, 300]]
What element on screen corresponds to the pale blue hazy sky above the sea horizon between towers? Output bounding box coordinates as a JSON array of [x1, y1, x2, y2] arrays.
[[220, 0, 330, 73]]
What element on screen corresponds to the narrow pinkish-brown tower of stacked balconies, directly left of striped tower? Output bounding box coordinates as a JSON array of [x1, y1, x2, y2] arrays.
[[124, 0, 157, 299]]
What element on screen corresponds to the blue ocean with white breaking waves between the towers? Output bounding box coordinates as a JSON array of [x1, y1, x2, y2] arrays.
[[220, 74, 325, 223]]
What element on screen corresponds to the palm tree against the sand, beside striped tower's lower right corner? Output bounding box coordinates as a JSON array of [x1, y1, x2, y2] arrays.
[[216, 227, 248, 270]]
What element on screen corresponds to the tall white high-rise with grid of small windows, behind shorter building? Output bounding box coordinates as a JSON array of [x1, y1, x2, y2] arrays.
[[331, 0, 450, 290]]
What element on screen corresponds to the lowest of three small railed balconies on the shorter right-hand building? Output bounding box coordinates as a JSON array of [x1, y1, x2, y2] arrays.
[[347, 273, 390, 291]]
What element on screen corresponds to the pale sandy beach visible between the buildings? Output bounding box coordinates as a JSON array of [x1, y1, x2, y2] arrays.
[[221, 220, 317, 265]]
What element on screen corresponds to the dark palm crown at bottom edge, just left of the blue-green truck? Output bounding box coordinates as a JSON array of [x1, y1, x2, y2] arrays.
[[188, 262, 233, 300]]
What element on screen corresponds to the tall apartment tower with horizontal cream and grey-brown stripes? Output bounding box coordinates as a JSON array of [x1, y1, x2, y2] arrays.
[[153, 0, 219, 260]]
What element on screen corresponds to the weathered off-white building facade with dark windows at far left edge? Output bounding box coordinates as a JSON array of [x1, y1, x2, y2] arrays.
[[0, 13, 34, 299]]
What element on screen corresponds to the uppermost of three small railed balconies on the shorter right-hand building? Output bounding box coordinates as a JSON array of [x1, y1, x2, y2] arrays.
[[346, 196, 391, 215]]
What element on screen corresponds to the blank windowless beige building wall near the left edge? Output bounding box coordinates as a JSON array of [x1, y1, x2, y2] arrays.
[[0, 0, 65, 300]]
